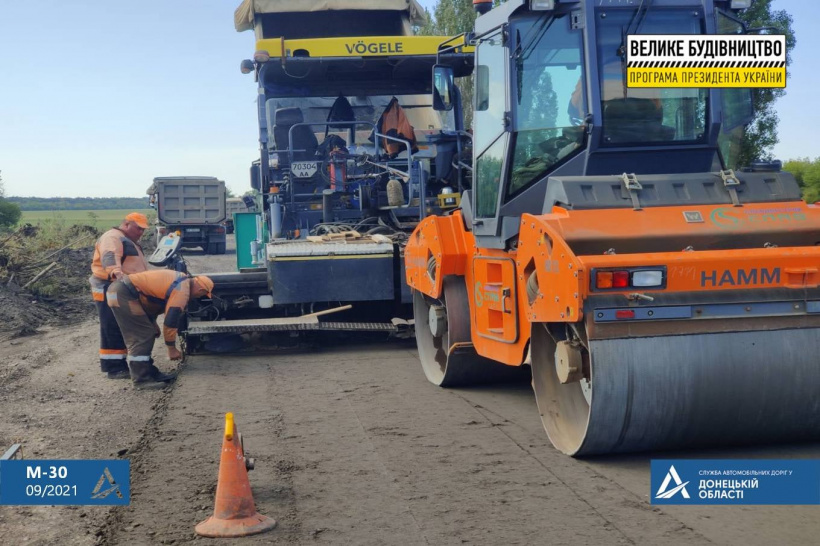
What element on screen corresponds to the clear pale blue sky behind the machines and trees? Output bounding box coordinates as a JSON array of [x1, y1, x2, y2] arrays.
[[0, 0, 820, 197]]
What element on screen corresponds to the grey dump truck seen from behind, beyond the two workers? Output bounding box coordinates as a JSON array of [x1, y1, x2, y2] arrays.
[[146, 176, 226, 254]]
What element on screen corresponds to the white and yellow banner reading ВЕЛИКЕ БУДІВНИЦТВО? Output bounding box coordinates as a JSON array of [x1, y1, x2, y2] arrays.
[[627, 34, 786, 87]]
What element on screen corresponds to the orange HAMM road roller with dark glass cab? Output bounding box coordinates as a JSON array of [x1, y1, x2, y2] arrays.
[[405, 0, 820, 456]]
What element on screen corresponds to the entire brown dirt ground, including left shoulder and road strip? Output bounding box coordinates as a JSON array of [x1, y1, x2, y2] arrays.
[[0, 236, 820, 545]]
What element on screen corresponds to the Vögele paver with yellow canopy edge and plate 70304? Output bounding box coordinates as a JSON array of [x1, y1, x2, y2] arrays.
[[179, 0, 473, 347]]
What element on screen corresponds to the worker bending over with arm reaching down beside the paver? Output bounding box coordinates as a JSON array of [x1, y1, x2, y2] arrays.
[[106, 269, 214, 389]]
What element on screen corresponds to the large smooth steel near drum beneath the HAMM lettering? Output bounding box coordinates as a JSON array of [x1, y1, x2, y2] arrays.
[[532, 324, 820, 456]]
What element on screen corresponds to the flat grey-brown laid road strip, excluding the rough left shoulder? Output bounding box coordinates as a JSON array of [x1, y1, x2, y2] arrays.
[[107, 343, 820, 544]]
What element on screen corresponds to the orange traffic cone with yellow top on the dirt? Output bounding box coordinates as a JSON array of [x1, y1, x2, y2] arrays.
[[195, 413, 276, 538]]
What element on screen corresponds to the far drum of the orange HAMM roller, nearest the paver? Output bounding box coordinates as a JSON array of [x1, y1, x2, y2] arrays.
[[413, 277, 529, 387]]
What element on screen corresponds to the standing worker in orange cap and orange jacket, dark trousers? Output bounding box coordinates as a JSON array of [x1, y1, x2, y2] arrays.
[[89, 212, 148, 379]]
